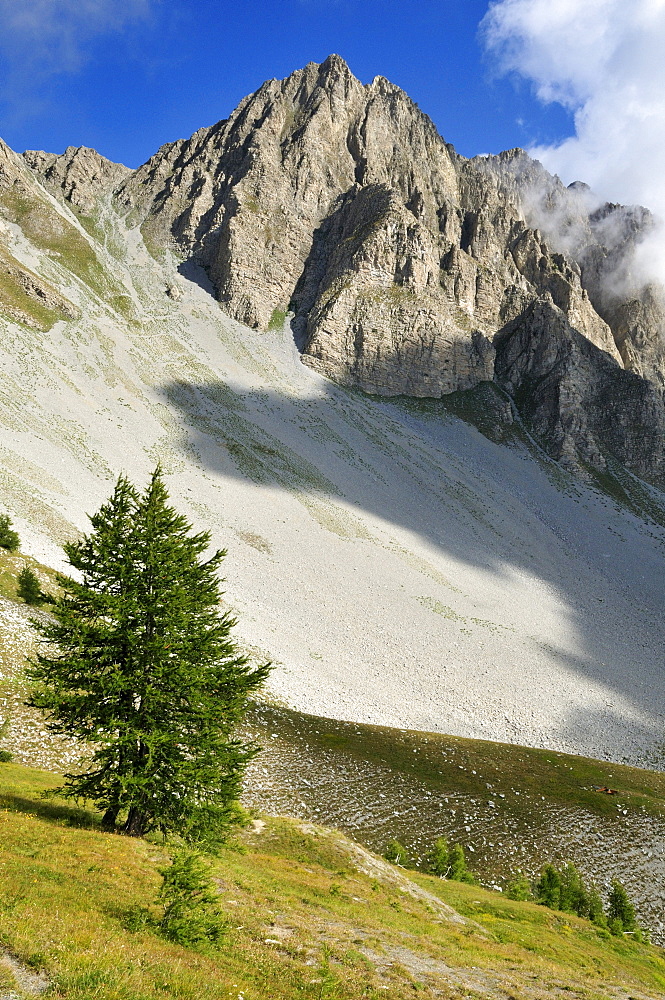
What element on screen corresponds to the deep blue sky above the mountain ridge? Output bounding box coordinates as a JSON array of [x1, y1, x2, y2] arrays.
[[0, 0, 572, 167]]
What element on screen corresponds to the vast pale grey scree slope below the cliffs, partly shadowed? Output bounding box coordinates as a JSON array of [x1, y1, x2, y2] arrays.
[[0, 160, 665, 761]]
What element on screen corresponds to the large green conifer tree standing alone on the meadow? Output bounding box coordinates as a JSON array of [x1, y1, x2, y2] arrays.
[[29, 467, 269, 846]]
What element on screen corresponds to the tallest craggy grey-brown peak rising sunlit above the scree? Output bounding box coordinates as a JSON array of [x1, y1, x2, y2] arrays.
[[117, 56, 620, 395]]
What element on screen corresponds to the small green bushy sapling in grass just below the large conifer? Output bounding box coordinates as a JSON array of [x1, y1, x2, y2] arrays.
[[157, 850, 225, 948]]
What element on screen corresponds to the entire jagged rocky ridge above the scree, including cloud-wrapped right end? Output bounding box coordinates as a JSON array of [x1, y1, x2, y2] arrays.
[[14, 56, 665, 480]]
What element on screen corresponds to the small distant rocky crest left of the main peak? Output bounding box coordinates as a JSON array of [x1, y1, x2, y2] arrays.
[[23, 146, 131, 215]]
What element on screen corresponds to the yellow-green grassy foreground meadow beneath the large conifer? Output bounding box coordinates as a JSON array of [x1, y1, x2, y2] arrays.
[[0, 764, 665, 1000]]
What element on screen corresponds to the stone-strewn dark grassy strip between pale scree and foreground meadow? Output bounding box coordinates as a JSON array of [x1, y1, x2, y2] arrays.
[[0, 588, 665, 944]]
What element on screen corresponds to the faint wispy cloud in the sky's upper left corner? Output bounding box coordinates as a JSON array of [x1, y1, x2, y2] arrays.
[[0, 0, 159, 123]]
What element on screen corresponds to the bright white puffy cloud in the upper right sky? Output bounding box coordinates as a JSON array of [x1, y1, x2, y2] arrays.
[[481, 0, 665, 278]]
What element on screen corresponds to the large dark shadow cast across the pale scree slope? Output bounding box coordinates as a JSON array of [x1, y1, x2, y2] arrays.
[[162, 381, 665, 747]]
